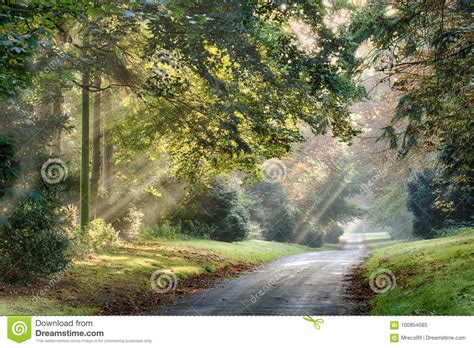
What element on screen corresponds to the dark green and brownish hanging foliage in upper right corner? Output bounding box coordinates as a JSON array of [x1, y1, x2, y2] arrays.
[[349, 0, 474, 175]]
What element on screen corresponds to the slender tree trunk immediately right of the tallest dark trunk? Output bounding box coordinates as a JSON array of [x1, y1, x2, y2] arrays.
[[91, 71, 101, 218]]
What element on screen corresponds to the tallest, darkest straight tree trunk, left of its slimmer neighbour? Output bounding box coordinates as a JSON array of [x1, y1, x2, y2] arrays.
[[79, 24, 90, 233]]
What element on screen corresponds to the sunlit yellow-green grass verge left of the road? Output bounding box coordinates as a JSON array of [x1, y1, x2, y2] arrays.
[[0, 240, 330, 315]]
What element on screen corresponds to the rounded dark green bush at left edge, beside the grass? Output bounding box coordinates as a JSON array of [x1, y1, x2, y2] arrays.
[[0, 187, 69, 282]]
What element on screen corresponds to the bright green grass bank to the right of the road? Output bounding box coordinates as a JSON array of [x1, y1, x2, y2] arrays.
[[364, 228, 474, 315]]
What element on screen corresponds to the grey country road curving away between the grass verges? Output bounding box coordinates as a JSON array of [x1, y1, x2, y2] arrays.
[[155, 227, 367, 315]]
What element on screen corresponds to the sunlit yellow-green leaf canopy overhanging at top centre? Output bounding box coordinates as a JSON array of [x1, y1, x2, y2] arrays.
[[111, 0, 362, 180]]
